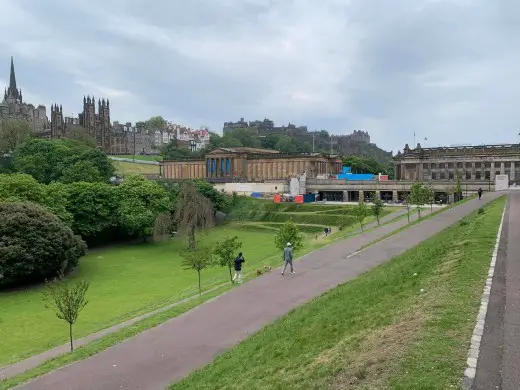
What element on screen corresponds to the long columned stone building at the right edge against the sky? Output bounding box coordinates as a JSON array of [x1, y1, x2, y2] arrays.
[[394, 144, 520, 182]]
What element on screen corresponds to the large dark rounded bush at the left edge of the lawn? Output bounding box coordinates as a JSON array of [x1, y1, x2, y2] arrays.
[[0, 203, 86, 287]]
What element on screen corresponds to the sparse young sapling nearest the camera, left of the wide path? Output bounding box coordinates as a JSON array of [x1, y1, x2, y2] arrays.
[[43, 281, 89, 352]]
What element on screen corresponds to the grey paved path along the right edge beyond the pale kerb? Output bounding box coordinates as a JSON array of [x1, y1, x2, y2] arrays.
[[472, 191, 520, 390]]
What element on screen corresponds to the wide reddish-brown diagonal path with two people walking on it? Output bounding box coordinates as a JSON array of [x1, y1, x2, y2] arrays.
[[16, 193, 499, 390]]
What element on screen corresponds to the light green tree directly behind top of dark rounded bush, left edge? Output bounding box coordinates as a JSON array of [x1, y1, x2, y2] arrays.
[[0, 174, 73, 226]]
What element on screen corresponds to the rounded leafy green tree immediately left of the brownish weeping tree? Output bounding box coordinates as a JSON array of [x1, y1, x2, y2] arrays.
[[117, 176, 170, 241]]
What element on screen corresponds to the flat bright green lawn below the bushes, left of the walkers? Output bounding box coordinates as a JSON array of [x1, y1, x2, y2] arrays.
[[0, 227, 279, 366]]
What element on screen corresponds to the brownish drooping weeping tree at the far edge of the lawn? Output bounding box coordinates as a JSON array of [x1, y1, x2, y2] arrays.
[[154, 182, 214, 250]]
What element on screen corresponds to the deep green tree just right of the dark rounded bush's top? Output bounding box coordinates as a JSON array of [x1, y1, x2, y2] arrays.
[[65, 182, 119, 238]]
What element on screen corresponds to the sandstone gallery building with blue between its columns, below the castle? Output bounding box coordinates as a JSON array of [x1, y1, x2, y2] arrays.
[[160, 147, 341, 182]]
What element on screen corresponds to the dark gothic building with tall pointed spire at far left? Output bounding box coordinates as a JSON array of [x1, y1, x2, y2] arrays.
[[0, 57, 49, 135]]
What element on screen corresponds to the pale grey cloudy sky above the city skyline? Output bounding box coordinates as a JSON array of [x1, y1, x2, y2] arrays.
[[0, 0, 520, 152]]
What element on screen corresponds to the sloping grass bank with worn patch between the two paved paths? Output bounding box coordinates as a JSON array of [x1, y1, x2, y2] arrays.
[[171, 197, 505, 390]]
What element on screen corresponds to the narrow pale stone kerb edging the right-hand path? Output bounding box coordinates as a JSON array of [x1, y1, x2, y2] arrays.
[[461, 198, 509, 390]]
